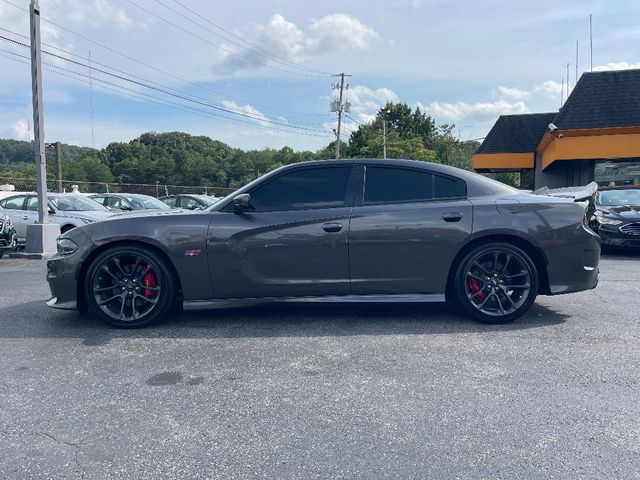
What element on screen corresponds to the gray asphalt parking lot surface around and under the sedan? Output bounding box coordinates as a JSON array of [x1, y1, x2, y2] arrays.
[[0, 254, 640, 479]]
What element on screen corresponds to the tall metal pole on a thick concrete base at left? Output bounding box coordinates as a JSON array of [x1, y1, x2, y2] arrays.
[[25, 0, 60, 256]]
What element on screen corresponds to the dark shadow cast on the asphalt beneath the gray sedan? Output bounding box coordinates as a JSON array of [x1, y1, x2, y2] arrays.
[[0, 302, 570, 346]]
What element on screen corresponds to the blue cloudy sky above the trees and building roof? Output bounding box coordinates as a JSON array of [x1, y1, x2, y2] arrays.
[[0, 0, 640, 150]]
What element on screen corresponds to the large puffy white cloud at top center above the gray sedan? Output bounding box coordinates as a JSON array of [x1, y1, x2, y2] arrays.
[[214, 13, 379, 73]]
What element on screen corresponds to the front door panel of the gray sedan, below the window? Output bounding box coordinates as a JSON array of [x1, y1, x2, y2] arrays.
[[207, 207, 351, 298]]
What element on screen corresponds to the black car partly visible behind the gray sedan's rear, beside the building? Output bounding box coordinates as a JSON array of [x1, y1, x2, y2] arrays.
[[592, 186, 640, 247]]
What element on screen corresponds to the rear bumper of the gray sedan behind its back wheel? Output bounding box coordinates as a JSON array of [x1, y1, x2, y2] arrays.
[[544, 224, 600, 295]]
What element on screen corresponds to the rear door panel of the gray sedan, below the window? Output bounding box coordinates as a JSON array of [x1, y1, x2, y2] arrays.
[[349, 200, 472, 294]]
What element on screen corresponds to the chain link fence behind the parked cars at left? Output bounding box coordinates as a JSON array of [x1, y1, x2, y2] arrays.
[[0, 175, 234, 197]]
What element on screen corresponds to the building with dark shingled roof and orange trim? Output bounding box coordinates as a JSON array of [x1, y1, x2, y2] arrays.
[[473, 69, 640, 188]]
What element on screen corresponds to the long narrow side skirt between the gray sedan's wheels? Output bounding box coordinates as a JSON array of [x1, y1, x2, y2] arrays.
[[183, 293, 445, 310]]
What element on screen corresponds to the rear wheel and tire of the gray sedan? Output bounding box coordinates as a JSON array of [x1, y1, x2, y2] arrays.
[[454, 242, 539, 324]]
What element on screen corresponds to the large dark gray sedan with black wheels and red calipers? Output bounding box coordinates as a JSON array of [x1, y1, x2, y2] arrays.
[[47, 159, 600, 327]]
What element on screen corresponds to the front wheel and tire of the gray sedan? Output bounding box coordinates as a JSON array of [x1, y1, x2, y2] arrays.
[[84, 245, 176, 328]]
